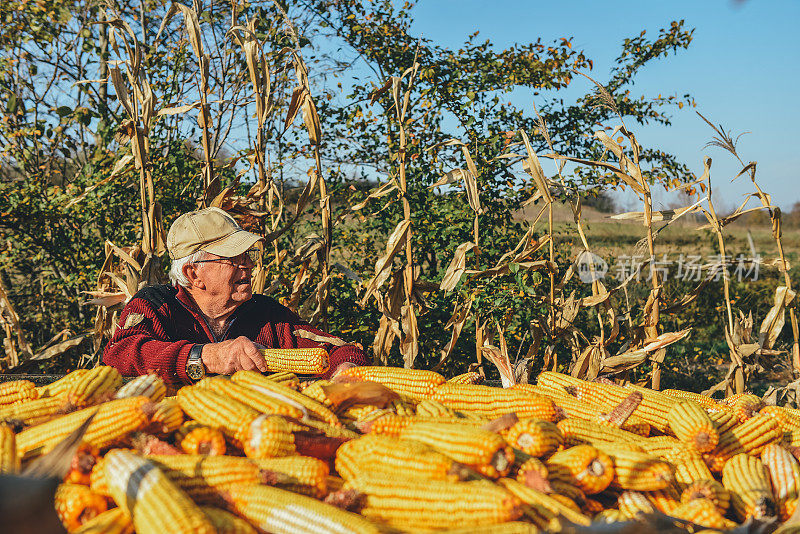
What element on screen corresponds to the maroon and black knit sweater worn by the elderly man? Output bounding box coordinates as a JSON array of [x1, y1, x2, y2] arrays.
[[103, 285, 368, 384]]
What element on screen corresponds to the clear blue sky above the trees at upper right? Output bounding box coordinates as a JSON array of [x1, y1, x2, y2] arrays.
[[406, 0, 800, 214]]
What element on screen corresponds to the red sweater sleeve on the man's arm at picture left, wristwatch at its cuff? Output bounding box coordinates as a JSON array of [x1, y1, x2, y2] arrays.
[[103, 297, 193, 384]]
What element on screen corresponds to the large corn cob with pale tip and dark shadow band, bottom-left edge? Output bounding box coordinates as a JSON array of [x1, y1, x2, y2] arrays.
[[104, 450, 214, 534]]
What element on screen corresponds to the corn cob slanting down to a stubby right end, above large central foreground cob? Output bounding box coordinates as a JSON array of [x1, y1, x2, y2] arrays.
[[400, 423, 514, 478]]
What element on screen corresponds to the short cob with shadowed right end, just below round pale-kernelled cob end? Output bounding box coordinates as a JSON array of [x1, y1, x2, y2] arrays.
[[252, 456, 330, 499]]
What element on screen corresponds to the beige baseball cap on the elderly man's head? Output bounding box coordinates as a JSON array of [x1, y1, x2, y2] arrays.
[[167, 208, 264, 260]]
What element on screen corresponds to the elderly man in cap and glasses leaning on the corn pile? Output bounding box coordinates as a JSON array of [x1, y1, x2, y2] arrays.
[[103, 208, 368, 383]]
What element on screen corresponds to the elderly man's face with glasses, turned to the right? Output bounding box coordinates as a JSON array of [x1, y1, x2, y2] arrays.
[[196, 252, 253, 307]]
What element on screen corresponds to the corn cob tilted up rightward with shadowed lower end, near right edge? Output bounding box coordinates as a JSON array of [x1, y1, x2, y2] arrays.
[[706, 415, 783, 472]]
